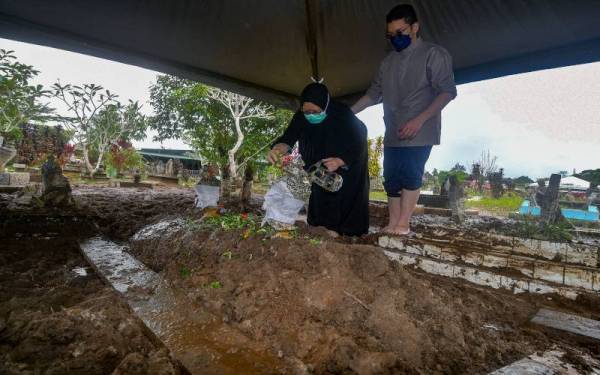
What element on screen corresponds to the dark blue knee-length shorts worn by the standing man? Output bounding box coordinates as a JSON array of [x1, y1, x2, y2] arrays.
[[383, 146, 432, 197]]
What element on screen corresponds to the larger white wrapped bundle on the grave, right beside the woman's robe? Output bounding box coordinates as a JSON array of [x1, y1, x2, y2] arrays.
[[262, 179, 304, 225]]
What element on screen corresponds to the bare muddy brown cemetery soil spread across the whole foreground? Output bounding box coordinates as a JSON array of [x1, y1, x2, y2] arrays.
[[0, 185, 600, 374]]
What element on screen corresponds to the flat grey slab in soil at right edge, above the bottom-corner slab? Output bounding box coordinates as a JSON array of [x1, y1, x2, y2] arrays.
[[531, 309, 600, 340]]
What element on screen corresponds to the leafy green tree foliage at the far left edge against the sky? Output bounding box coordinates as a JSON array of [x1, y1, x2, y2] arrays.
[[0, 49, 54, 140]]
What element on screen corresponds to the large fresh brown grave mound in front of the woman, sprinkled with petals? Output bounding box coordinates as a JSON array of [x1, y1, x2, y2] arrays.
[[131, 217, 597, 374]]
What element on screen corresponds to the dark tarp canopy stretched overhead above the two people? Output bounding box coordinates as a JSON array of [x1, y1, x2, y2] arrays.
[[0, 0, 600, 106]]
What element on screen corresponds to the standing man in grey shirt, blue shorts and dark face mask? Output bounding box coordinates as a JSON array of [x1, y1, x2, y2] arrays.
[[352, 4, 456, 235]]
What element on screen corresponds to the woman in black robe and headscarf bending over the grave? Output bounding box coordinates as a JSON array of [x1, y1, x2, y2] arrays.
[[269, 83, 369, 236]]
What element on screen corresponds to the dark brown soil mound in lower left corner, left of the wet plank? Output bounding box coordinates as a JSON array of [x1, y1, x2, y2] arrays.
[[0, 234, 182, 375]]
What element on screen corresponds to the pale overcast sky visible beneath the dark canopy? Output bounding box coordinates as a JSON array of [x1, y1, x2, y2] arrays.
[[0, 39, 600, 177]]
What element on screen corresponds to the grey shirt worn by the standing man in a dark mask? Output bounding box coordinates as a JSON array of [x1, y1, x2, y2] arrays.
[[367, 39, 456, 147]]
